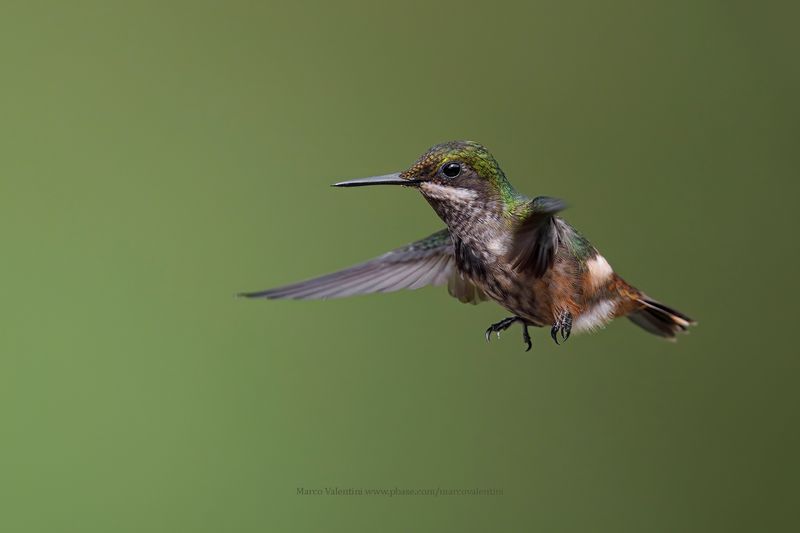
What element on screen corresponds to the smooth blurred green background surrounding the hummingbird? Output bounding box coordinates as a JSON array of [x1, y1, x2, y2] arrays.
[[0, 1, 800, 532]]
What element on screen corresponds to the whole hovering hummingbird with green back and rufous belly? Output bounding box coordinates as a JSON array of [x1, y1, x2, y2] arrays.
[[242, 141, 695, 351]]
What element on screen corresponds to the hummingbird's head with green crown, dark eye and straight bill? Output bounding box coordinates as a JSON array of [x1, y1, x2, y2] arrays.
[[334, 141, 516, 204]]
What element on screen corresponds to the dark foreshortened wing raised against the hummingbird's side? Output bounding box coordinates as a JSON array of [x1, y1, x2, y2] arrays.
[[509, 196, 567, 278]]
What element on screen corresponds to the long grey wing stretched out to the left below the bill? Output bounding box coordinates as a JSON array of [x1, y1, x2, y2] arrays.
[[241, 229, 486, 303]]
